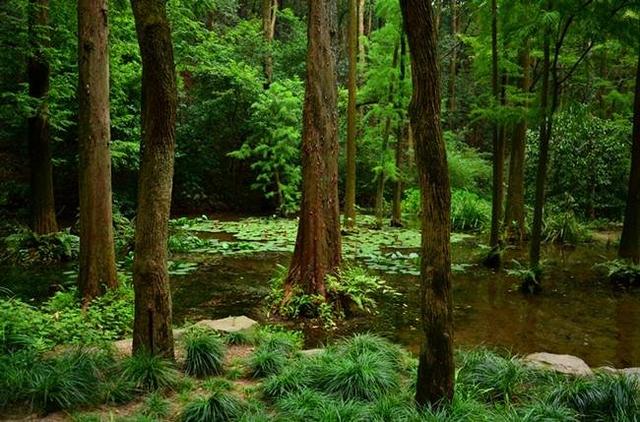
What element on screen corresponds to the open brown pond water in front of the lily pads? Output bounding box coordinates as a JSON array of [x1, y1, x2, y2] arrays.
[[173, 237, 640, 367]]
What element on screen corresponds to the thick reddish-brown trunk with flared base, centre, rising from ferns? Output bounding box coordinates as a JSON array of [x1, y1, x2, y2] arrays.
[[285, 1, 342, 301]]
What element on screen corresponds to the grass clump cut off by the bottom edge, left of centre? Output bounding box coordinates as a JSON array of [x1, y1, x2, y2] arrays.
[[181, 391, 244, 422]]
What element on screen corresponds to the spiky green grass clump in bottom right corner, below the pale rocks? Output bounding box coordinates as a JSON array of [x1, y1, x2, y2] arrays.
[[550, 374, 640, 422]]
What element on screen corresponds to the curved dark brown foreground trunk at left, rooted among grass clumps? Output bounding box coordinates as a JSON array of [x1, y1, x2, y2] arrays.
[[131, 0, 177, 358]]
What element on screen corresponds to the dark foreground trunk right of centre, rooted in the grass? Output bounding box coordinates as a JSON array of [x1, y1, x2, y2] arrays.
[[400, 0, 454, 407]]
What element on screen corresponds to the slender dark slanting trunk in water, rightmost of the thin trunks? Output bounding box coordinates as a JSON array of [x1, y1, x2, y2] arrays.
[[523, 29, 552, 284]]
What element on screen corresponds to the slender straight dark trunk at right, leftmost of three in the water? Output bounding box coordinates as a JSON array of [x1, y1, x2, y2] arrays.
[[485, 0, 504, 268]]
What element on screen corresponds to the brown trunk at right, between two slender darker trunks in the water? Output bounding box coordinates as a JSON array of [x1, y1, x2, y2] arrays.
[[504, 47, 531, 242]]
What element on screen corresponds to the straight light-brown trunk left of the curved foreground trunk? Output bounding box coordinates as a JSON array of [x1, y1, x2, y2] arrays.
[[78, 0, 118, 304]]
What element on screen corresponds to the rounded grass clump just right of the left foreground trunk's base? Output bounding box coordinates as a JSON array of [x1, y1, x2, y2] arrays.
[[185, 330, 226, 377]]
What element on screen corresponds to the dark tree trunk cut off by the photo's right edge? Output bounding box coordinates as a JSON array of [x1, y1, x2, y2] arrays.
[[618, 48, 640, 263]]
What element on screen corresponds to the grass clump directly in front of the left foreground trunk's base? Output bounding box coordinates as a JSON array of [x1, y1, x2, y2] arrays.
[[122, 353, 180, 391]]
